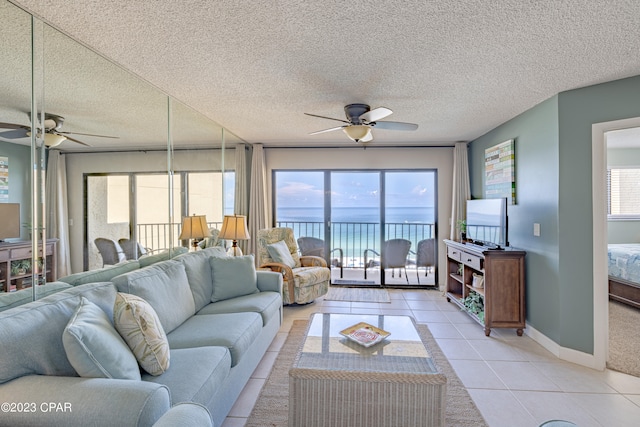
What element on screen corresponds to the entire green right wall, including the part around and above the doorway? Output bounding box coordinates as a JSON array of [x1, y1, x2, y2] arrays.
[[469, 76, 640, 354]]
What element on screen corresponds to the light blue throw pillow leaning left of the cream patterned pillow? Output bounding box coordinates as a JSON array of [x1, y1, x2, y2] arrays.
[[62, 297, 140, 380]]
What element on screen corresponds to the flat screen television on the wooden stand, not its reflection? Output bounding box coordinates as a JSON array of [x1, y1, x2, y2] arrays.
[[467, 197, 509, 248]]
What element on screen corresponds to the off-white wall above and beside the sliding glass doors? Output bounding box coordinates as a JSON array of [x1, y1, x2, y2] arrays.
[[264, 147, 453, 288]]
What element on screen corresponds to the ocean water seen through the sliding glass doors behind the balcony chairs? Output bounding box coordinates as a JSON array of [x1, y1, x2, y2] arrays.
[[276, 207, 435, 268]]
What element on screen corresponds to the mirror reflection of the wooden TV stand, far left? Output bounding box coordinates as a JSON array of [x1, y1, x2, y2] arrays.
[[0, 239, 58, 292]]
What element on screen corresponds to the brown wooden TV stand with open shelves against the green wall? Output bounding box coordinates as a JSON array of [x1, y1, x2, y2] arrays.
[[444, 240, 526, 336]]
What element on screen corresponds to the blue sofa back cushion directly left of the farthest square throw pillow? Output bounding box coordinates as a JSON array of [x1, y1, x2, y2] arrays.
[[174, 247, 228, 311]]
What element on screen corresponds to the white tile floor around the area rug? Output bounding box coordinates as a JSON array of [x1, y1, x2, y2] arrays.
[[223, 290, 640, 427]]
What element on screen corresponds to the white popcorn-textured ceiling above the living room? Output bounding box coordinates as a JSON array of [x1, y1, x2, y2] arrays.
[[0, 0, 640, 150]]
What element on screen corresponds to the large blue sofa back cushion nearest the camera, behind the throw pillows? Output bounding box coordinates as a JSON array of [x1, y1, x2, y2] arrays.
[[0, 282, 116, 383]]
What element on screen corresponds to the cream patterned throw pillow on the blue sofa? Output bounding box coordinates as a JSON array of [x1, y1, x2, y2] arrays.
[[113, 292, 169, 375]]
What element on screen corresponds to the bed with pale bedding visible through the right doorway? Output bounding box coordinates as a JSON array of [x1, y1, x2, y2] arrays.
[[608, 243, 640, 308]]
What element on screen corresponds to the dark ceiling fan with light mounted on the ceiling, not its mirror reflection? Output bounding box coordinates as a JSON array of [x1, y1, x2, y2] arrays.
[[305, 104, 418, 142]]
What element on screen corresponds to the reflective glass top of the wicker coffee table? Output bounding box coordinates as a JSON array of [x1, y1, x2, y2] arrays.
[[294, 313, 437, 373]]
